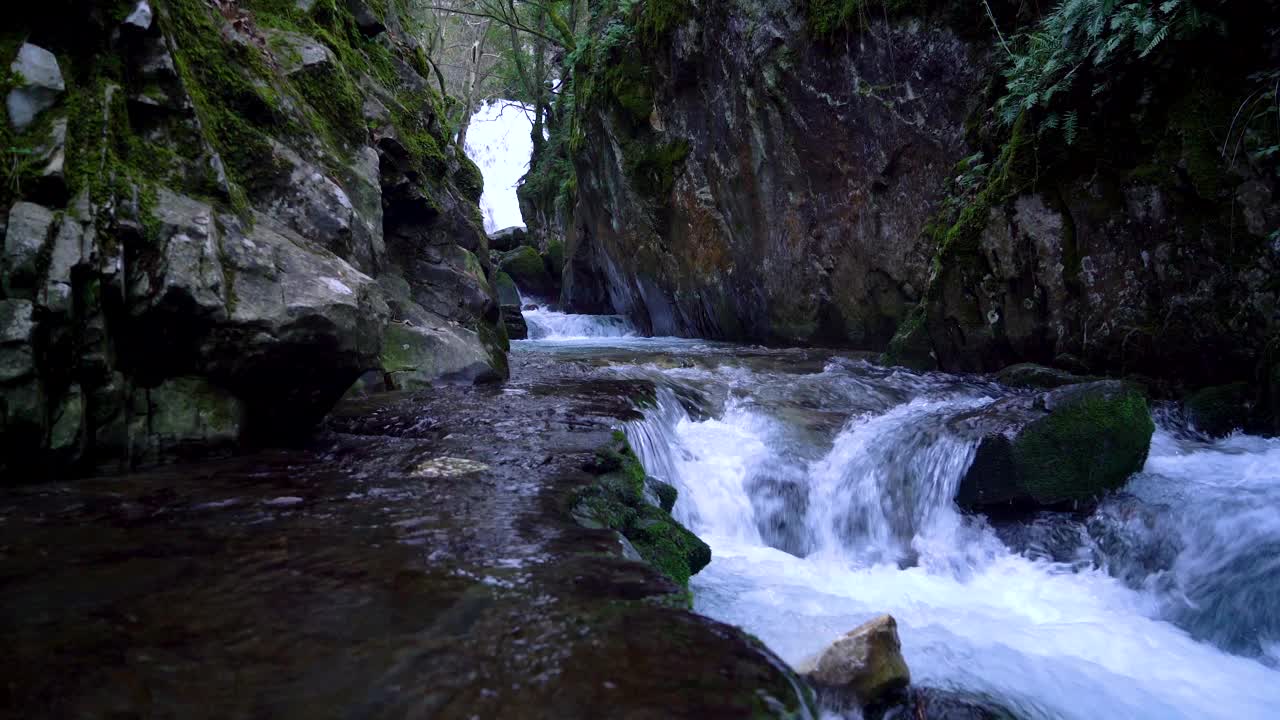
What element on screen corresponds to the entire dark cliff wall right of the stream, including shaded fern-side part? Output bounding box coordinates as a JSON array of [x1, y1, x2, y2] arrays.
[[552, 0, 1280, 415]]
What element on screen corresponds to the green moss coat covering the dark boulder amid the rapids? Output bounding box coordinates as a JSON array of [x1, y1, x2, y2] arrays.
[[1012, 387, 1156, 505]]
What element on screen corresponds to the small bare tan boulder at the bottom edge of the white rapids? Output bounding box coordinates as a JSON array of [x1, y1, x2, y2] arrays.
[[799, 615, 911, 707]]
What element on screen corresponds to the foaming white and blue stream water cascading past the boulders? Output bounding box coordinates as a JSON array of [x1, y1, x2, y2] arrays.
[[516, 311, 1280, 720]]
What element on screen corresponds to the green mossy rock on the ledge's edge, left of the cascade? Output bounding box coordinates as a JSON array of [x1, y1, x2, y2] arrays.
[[572, 433, 712, 587]]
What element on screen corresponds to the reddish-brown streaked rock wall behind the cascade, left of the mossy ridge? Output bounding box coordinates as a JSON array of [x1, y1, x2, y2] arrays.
[[564, 1, 983, 347]]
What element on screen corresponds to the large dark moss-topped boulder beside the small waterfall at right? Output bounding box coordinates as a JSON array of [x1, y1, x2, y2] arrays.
[[956, 380, 1156, 510]]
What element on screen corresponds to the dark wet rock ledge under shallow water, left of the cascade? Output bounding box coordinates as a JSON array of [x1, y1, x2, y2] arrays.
[[0, 345, 808, 719]]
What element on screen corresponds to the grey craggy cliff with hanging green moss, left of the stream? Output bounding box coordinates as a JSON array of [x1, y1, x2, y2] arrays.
[[0, 0, 506, 480]]
